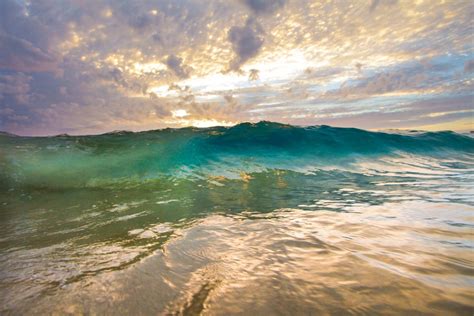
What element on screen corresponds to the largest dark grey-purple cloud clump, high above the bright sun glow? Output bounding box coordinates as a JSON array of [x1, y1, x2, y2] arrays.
[[228, 18, 264, 70]]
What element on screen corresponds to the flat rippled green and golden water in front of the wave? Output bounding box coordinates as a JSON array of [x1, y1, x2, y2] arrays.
[[0, 153, 474, 315]]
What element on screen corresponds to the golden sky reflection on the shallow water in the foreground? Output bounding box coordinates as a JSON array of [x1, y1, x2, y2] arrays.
[[22, 201, 474, 315]]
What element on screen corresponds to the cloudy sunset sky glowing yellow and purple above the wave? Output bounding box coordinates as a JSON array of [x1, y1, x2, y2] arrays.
[[0, 0, 474, 135]]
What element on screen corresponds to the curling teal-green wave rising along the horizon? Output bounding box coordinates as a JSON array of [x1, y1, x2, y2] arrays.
[[0, 122, 474, 188]]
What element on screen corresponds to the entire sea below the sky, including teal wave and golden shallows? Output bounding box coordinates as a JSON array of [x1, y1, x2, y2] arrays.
[[0, 123, 474, 315]]
